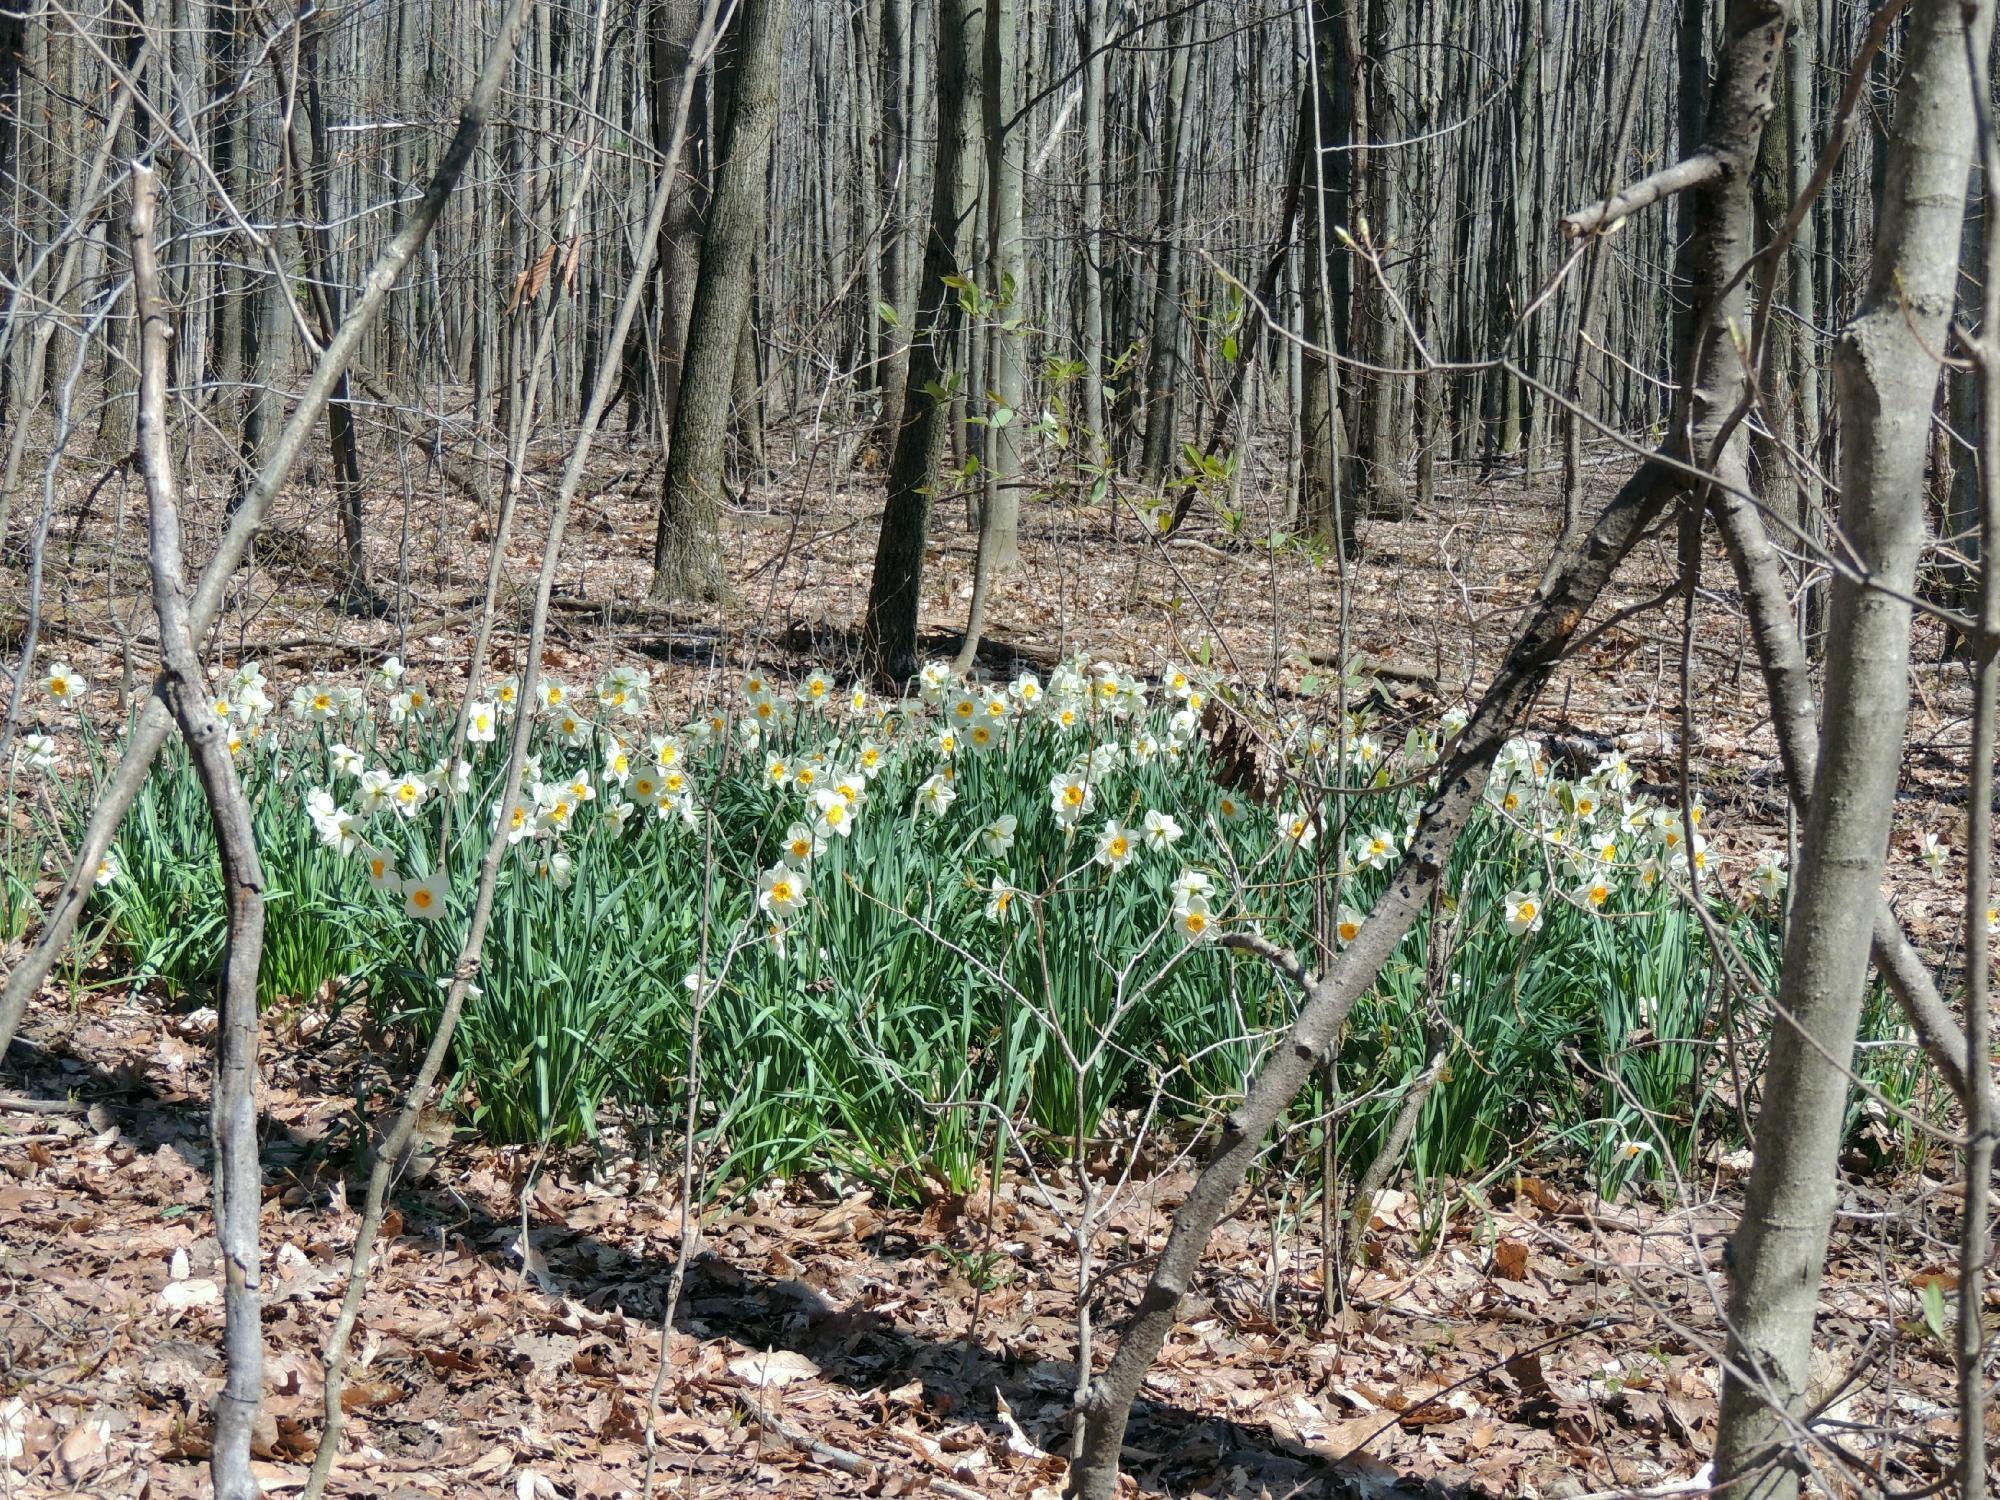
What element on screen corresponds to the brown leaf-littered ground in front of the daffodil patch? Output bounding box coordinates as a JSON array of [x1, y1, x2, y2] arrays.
[[0, 992, 1954, 1500]]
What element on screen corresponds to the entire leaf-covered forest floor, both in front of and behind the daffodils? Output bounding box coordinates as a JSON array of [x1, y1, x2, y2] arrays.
[[0, 426, 1966, 1500]]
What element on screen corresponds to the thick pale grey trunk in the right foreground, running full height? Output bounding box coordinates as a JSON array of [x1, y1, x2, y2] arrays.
[[1716, 0, 1992, 1500]]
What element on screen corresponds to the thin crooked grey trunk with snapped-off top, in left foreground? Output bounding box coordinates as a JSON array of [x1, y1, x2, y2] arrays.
[[130, 162, 264, 1500]]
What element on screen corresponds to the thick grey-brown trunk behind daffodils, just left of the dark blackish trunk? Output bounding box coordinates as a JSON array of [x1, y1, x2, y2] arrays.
[[652, 0, 788, 604]]
